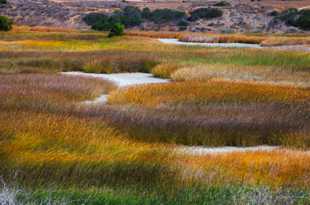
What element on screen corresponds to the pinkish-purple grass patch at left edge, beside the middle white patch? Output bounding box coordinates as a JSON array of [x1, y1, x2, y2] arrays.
[[0, 74, 115, 111]]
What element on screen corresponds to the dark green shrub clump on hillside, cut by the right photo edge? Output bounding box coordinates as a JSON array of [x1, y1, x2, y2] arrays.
[[276, 8, 310, 30]]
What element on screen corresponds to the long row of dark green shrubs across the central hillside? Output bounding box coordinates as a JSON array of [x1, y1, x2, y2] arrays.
[[84, 6, 226, 31]]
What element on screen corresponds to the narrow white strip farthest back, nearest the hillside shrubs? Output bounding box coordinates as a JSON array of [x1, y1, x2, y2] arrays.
[[159, 38, 262, 48]]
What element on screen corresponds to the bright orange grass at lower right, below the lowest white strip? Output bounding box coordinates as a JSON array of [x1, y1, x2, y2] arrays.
[[181, 150, 310, 188]]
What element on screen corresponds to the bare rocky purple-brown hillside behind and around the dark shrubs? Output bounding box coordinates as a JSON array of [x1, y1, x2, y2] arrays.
[[0, 0, 310, 32]]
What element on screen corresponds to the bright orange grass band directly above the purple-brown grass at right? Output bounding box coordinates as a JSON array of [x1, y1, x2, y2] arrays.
[[109, 81, 310, 107]]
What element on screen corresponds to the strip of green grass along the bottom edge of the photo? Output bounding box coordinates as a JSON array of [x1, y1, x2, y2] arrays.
[[13, 186, 310, 205]]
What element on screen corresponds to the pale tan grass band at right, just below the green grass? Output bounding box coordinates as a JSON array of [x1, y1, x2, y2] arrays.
[[169, 64, 310, 87]]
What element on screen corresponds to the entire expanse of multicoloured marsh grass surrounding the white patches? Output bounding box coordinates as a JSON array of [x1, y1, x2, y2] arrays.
[[0, 28, 310, 205]]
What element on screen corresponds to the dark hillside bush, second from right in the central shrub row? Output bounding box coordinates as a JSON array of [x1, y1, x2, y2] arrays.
[[150, 9, 186, 24]]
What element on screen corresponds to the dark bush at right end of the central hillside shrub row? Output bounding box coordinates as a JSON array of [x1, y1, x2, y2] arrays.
[[189, 8, 223, 21]]
